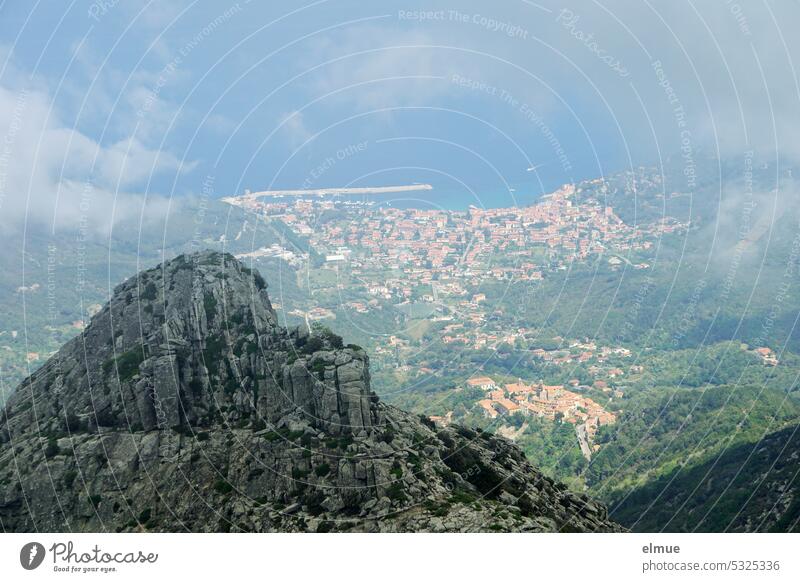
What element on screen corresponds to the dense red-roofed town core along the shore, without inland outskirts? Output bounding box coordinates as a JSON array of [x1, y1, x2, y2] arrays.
[[231, 185, 682, 301]]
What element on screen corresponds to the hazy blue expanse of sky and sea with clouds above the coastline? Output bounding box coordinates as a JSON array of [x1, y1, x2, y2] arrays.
[[0, 0, 800, 233]]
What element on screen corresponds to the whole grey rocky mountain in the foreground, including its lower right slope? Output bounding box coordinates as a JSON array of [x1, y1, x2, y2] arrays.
[[0, 252, 620, 531]]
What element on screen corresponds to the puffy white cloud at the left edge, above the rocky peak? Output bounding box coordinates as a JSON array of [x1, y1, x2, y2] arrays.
[[0, 81, 191, 233]]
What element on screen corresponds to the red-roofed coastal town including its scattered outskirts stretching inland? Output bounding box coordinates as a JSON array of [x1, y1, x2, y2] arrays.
[[219, 181, 687, 378]]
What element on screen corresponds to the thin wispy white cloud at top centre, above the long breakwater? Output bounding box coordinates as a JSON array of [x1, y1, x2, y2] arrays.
[[303, 20, 550, 110]]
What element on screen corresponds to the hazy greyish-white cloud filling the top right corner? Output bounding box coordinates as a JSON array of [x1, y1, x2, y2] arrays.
[[540, 0, 800, 158]]
